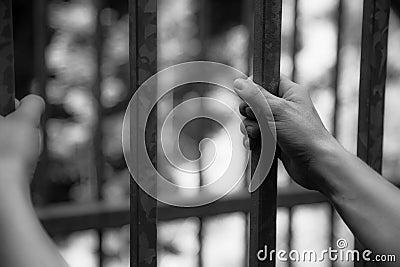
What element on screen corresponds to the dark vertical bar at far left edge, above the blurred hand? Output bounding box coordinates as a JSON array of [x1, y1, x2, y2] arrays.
[[0, 0, 15, 116]]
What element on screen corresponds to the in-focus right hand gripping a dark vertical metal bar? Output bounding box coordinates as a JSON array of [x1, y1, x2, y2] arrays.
[[234, 77, 341, 194]]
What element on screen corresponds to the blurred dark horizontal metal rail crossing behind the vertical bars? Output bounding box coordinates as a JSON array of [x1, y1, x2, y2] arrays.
[[37, 186, 327, 234]]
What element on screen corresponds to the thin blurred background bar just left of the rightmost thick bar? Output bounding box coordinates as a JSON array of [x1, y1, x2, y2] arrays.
[[329, 0, 343, 267]]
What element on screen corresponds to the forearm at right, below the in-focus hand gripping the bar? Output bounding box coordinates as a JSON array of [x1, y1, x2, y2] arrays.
[[318, 147, 400, 259]]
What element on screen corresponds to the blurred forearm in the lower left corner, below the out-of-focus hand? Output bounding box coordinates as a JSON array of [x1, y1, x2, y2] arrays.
[[0, 163, 67, 267]]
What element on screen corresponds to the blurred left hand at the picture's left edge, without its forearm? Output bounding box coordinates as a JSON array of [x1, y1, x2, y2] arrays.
[[0, 95, 44, 185]]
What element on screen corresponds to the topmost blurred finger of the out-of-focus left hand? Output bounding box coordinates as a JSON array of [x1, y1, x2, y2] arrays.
[[9, 95, 45, 126]]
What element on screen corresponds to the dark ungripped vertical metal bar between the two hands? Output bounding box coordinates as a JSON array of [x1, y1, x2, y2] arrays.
[[129, 0, 157, 267]]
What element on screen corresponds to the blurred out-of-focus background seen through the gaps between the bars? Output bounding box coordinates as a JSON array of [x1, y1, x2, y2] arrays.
[[13, 0, 400, 267]]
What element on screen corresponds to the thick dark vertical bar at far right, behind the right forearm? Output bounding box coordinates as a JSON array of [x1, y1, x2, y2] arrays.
[[355, 0, 390, 266]]
